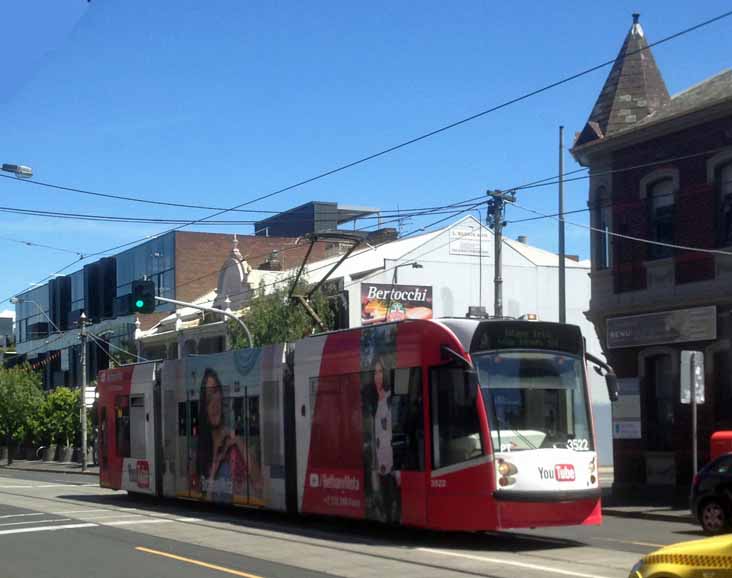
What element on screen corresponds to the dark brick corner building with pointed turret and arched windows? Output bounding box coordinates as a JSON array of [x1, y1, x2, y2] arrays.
[[572, 14, 732, 492]]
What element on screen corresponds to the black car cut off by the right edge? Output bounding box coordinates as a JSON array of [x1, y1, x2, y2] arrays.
[[689, 452, 732, 534]]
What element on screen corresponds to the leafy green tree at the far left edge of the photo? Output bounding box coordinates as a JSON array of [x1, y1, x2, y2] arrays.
[[0, 364, 43, 455]]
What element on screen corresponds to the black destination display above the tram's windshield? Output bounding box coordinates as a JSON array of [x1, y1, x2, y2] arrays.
[[470, 321, 582, 355]]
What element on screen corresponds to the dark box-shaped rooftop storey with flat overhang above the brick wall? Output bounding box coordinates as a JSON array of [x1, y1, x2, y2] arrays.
[[254, 201, 379, 237]]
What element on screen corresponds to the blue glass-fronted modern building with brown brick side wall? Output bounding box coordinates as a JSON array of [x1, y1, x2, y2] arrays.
[[10, 231, 326, 387]]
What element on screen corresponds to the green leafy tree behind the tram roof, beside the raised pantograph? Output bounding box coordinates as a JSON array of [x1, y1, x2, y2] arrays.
[[229, 279, 335, 348]]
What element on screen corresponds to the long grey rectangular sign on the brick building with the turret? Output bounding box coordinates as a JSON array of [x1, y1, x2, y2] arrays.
[[607, 305, 717, 349]]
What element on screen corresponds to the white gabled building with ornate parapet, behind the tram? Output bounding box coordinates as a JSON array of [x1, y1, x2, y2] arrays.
[[139, 217, 612, 466]]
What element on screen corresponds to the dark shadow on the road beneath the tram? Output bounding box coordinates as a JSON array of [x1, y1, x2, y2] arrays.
[[58, 493, 586, 553]]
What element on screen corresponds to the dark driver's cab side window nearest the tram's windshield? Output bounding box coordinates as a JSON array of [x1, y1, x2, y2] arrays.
[[431, 366, 483, 469]]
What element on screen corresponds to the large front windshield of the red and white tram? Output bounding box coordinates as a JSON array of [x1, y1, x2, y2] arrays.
[[473, 350, 594, 452]]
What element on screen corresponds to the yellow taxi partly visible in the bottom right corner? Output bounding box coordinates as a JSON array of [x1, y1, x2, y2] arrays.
[[628, 535, 732, 578]]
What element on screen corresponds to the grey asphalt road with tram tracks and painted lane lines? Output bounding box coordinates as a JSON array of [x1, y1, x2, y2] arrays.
[[0, 470, 701, 578]]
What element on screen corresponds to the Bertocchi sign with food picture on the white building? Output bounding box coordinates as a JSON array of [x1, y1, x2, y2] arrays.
[[361, 283, 432, 325]]
